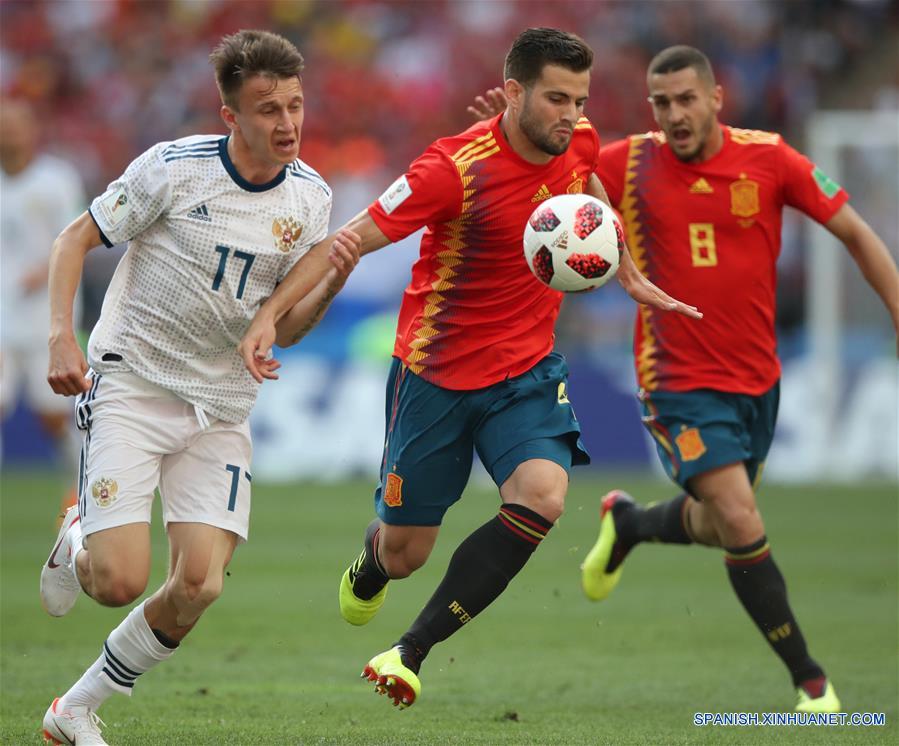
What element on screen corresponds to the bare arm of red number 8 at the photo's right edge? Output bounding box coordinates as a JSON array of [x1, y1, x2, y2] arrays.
[[825, 204, 899, 335]]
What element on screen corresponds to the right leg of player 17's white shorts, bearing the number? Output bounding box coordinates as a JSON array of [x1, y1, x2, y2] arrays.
[[159, 420, 253, 541]]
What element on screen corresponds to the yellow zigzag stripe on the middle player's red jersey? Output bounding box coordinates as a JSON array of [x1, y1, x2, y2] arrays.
[[406, 131, 499, 374]]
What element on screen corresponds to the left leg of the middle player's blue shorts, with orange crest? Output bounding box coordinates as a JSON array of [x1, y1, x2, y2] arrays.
[[375, 359, 473, 526]]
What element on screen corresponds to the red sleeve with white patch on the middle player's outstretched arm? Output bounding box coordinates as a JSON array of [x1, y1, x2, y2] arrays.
[[368, 145, 462, 242]]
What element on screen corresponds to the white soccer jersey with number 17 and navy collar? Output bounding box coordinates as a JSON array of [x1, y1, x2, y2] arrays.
[[88, 135, 331, 423]]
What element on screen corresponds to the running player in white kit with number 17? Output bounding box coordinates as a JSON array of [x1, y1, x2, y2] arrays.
[[41, 31, 358, 746]]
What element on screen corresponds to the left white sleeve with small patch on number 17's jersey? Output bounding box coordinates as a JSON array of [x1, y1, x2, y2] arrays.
[[90, 143, 172, 246]]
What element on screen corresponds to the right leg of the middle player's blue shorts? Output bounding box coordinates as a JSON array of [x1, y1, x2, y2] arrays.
[[475, 353, 590, 488]]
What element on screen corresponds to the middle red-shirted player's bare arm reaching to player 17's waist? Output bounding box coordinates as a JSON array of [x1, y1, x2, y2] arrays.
[[237, 210, 390, 383]]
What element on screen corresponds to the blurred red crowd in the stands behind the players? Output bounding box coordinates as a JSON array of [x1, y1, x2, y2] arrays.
[[0, 0, 899, 476]]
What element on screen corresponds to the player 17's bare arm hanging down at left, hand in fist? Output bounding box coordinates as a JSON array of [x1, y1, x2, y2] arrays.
[[47, 212, 102, 396]]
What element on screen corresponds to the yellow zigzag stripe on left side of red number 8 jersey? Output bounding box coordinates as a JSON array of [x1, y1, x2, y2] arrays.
[[621, 133, 658, 391]]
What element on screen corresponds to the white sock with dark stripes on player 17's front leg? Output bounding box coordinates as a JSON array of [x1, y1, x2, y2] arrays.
[[60, 602, 175, 710]]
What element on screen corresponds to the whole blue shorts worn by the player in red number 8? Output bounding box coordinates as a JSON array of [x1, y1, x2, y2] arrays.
[[640, 382, 780, 489]]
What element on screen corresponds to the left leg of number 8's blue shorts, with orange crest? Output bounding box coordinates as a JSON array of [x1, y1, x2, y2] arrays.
[[641, 389, 753, 489]]
